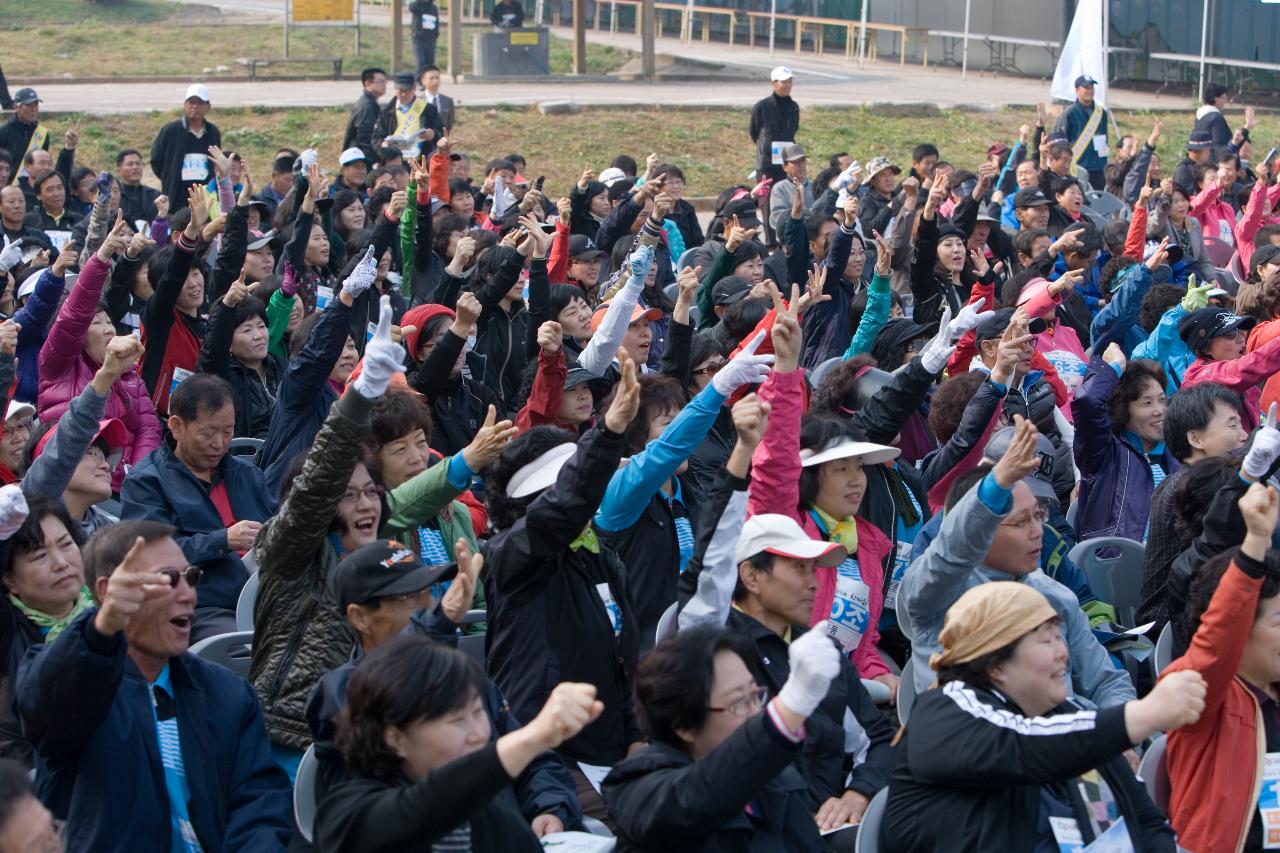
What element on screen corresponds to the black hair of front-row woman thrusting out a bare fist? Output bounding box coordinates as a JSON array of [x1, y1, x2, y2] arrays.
[[338, 635, 488, 784]]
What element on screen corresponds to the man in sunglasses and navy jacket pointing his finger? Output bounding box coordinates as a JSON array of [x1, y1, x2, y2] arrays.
[[15, 521, 292, 853]]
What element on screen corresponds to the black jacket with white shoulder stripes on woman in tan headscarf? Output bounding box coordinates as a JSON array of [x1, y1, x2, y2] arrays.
[[881, 681, 1175, 853]]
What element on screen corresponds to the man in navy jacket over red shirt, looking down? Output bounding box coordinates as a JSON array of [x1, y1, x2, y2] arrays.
[[120, 373, 275, 640]]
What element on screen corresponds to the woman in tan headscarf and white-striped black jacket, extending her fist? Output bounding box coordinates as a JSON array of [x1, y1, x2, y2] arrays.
[[879, 581, 1192, 853]]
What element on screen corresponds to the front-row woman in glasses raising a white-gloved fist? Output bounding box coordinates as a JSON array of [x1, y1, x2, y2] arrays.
[[603, 625, 840, 853]]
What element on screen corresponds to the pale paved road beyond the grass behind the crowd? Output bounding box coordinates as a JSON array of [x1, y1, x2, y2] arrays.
[[30, 0, 1187, 113]]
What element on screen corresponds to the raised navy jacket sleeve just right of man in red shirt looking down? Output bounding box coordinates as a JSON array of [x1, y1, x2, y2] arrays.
[[257, 298, 351, 491]]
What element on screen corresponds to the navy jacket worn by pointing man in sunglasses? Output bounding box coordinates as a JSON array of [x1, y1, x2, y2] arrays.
[[15, 608, 293, 853]]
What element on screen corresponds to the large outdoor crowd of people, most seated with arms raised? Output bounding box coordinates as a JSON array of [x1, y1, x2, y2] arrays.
[[0, 54, 1280, 853]]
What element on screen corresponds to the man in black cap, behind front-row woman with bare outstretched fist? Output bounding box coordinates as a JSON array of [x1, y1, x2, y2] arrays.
[[307, 539, 582, 838]]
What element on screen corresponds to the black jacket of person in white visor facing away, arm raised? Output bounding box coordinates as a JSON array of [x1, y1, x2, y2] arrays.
[[484, 425, 643, 765]]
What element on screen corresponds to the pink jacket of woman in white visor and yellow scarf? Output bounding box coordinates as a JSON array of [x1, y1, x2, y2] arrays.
[[746, 370, 892, 679]]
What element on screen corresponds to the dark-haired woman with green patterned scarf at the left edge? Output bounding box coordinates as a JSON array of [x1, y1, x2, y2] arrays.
[[0, 485, 93, 767]]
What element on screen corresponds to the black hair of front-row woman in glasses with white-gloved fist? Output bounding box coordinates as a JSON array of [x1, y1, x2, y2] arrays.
[[635, 625, 755, 752]]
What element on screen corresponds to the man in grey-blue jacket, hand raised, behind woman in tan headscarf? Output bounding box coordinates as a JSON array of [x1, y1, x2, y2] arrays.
[[897, 415, 1137, 707]]
